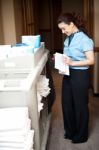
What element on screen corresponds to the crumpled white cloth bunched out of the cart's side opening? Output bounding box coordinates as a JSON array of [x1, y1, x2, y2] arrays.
[[37, 75, 50, 112]]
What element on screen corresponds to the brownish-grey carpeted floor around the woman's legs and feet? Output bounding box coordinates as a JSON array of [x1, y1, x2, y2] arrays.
[[47, 72, 99, 150]]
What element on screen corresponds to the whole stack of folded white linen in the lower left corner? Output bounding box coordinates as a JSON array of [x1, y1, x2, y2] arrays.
[[0, 107, 34, 150]]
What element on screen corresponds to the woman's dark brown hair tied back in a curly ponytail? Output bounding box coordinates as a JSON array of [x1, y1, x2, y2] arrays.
[[57, 12, 87, 34]]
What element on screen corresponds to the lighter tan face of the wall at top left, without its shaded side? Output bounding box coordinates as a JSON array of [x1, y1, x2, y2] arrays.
[[1, 0, 16, 44]]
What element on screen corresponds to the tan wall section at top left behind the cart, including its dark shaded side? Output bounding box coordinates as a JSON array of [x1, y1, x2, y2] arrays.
[[0, 0, 22, 44]]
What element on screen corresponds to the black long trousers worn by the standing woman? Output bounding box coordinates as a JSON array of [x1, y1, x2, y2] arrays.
[[62, 69, 89, 140]]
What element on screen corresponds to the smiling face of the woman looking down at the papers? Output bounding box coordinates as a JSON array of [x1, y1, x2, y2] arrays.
[[58, 22, 74, 36]]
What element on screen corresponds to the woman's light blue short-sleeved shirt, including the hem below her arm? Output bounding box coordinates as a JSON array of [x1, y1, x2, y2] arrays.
[[63, 31, 94, 69]]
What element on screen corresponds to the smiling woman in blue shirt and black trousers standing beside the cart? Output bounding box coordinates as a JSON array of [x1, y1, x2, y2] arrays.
[[58, 13, 94, 143]]
